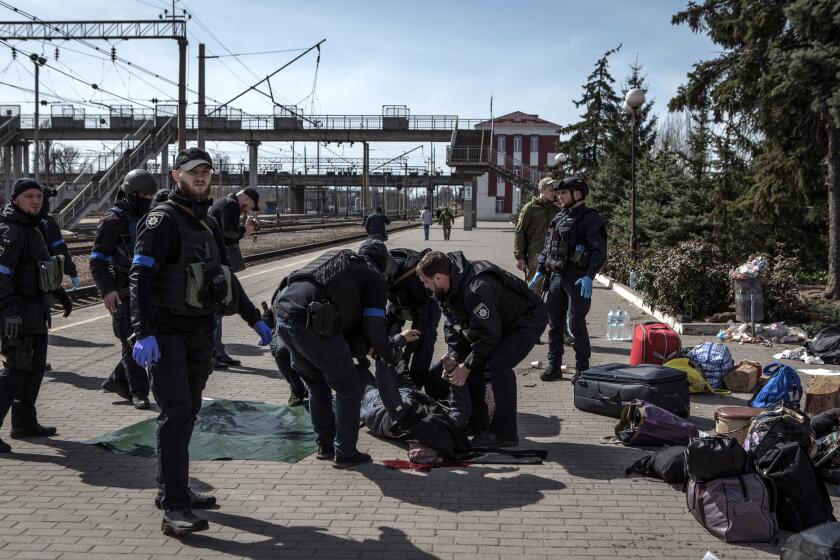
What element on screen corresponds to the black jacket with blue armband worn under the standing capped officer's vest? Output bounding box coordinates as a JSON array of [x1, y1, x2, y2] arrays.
[[129, 190, 260, 338]]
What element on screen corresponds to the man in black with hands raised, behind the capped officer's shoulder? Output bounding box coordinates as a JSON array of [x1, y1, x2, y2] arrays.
[[207, 188, 260, 369]]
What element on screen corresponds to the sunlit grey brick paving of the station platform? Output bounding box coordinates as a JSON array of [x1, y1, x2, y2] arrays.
[[0, 218, 840, 560]]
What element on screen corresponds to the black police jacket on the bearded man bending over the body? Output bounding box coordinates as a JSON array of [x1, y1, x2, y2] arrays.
[[436, 251, 545, 370]]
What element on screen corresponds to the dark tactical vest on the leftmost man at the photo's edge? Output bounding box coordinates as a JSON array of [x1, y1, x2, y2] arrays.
[[0, 218, 54, 334]]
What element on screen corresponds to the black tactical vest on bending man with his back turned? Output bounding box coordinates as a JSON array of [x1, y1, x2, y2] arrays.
[[288, 249, 367, 333]]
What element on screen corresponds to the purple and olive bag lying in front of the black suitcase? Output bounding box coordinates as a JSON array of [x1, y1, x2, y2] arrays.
[[615, 400, 698, 447]]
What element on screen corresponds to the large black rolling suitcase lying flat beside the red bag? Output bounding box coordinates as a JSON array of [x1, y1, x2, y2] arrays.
[[572, 364, 689, 418]]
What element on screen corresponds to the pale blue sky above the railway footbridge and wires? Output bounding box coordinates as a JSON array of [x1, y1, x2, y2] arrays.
[[0, 0, 716, 163]]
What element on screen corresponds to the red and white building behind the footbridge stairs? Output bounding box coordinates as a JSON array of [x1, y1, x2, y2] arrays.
[[475, 111, 560, 221]]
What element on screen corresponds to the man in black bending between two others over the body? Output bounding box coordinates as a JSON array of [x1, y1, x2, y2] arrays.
[[368, 248, 449, 400]]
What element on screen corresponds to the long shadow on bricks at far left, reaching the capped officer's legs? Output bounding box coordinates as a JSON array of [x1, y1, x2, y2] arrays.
[[3, 438, 213, 492]]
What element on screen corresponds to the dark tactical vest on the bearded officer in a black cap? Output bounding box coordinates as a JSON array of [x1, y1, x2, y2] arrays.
[[153, 201, 238, 316]]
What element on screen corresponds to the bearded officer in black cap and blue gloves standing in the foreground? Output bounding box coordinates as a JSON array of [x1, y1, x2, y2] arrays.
[[129, 148, 271, 535]]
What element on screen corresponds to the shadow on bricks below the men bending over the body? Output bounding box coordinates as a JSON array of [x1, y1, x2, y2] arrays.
[[353, 464, 566, 513]]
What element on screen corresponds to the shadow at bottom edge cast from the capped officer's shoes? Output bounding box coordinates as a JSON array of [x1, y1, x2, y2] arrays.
[[179, 511, 437, 560]]
